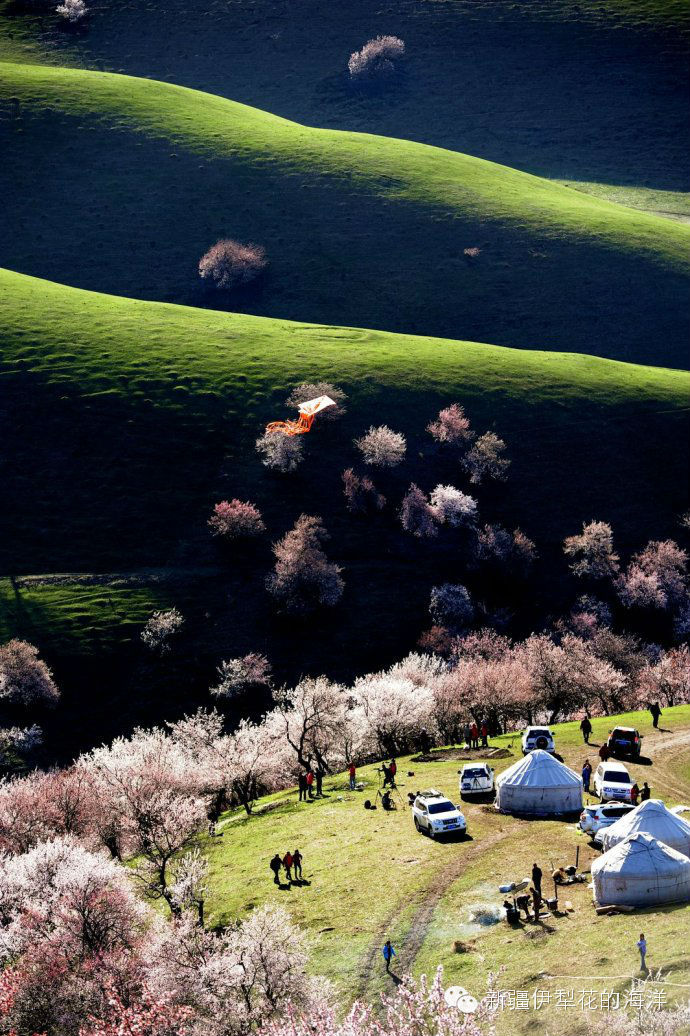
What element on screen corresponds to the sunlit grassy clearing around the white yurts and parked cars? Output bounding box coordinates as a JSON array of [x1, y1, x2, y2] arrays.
[[206, 706, 690, 1034]]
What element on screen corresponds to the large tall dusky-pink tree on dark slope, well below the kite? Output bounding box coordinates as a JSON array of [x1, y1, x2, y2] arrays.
[[266, 515, 345, 614]]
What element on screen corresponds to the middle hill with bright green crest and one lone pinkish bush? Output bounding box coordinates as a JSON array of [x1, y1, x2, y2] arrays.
[[0, 63, 690, 367]]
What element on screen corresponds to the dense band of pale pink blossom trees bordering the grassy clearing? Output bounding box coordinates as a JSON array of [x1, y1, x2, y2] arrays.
[[0, 613, 690, 1036]]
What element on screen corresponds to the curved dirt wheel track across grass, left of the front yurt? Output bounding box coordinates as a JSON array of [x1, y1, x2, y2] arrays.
[[356, 831, 510, 1000]]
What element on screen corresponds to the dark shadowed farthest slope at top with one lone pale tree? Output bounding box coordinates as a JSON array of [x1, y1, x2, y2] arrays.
[[0, 0, 690, 191]]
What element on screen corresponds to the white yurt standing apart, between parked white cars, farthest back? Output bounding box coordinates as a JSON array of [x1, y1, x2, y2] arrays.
[[496, 749, 582, 816]]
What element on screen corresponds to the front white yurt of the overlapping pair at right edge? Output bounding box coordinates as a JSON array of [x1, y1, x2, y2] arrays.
[[592, 832, 690, 907]]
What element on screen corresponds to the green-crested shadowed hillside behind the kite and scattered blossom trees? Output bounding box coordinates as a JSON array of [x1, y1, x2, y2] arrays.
[[0, 271, 690, 754]]
